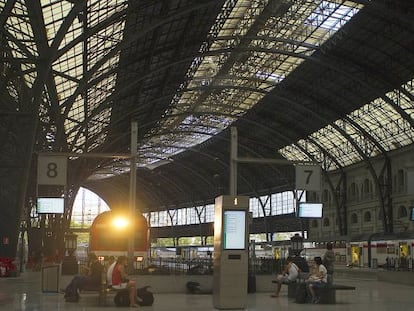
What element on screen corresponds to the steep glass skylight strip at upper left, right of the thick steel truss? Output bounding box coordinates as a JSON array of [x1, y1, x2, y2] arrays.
[[54, 0, 126, 148]]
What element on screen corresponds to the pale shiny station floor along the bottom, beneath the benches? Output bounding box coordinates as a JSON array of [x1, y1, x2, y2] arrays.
[[0, 271, 414, 311]]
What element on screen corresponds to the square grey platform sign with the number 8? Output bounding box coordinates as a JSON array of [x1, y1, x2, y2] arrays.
[[37, 156, 67, 185]]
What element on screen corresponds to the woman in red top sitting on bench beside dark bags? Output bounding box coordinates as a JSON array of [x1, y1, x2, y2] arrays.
[[112, 256, 138, 307]]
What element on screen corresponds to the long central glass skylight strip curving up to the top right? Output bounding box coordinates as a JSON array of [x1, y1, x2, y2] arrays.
[[140, 0, 361, 167]]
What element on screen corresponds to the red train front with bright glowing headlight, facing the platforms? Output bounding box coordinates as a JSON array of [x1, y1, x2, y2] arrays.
[[89, 211, 149, 262]]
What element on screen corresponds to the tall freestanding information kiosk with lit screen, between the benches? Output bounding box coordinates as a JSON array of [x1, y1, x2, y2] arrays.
[[213, 195, 249, 309]]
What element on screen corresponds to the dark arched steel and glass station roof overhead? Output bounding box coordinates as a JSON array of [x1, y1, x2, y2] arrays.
[[0, 0, 414, 256]]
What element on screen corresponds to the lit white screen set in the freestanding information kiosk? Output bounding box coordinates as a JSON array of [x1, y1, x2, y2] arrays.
[[223, 210, 246, 250]]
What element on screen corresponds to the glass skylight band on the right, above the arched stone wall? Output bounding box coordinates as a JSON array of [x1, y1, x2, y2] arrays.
[[279, 77, 414, 169]]
